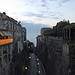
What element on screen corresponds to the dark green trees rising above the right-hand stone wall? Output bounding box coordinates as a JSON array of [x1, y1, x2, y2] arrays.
[[44, 19, 70, 37]]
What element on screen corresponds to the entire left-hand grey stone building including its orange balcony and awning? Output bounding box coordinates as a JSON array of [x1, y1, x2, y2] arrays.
[[0, 12, 26, 75]]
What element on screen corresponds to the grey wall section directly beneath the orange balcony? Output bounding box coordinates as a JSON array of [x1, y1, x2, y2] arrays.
[[0, 44, 13, 75]]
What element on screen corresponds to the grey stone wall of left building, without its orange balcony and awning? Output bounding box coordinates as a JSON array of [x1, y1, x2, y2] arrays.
[[0, 12, 26, 75]]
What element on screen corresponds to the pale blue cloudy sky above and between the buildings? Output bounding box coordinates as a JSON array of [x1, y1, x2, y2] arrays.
[[0, 0, 75, 44]]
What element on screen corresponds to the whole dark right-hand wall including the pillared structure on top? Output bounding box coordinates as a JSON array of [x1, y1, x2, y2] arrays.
[[36, 23, 75, 75]]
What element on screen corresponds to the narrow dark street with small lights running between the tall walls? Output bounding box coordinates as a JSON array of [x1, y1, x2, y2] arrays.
[[27, 53, 46, 75]]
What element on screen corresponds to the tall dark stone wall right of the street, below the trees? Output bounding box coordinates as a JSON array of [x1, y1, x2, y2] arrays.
[[37, 36, 69, 75]]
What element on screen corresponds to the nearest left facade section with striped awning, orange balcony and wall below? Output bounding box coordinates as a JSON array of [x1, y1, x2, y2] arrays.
[[0, 29, 13, 75]]
